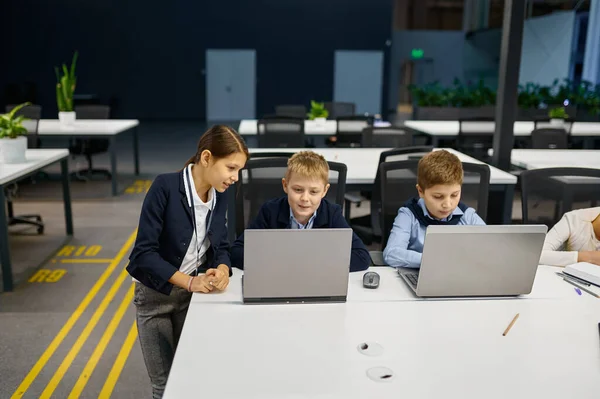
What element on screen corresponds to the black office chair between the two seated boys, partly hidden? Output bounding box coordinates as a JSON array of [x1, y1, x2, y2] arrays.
[[345, 146, 433, 245]]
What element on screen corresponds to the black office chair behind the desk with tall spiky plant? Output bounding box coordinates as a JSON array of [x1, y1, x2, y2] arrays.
[[69, 105, 112, 180]]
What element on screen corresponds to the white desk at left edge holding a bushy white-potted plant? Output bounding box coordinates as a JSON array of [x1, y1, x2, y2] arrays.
[[0, 149, 73, 291]]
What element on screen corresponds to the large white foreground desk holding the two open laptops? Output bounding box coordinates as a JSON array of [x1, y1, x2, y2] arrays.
[[164, 273, 600, 399]]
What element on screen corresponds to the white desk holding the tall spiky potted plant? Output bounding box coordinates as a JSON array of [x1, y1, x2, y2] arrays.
[[38, 119, 140, 196]]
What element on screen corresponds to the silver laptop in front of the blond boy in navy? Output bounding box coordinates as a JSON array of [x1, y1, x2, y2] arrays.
[[242, 228, 352, 303]]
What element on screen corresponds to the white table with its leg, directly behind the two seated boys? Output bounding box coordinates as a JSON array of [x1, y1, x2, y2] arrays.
[[250, 148, 517, 224]]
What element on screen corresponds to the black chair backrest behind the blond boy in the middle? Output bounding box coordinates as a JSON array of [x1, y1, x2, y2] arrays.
[[235, 154, 347, 236]]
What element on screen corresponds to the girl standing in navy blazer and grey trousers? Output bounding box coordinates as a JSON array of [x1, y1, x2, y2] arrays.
[[127, 125, 248, 399]]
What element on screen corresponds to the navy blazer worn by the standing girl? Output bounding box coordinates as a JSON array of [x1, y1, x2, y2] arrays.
[[127, 172, 232, 295]]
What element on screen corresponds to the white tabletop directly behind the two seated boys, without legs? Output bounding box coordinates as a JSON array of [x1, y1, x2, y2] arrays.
[[250, 148, 517, 184]]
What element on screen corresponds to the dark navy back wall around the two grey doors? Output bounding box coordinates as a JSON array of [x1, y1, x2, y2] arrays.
[[0, 0, 392, 119]]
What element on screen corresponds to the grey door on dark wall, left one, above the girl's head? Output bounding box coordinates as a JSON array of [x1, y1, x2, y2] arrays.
[[206, 50, 256, 121]]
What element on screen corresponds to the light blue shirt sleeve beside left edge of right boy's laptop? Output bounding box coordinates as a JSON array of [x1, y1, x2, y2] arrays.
[[383, 208, 422, 268]]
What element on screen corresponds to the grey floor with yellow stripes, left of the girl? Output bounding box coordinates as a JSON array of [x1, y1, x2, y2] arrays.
[[0, 122, 532, 399]]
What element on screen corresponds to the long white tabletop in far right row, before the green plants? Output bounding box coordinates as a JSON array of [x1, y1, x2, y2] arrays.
[[404, 121, 600, 136]]
